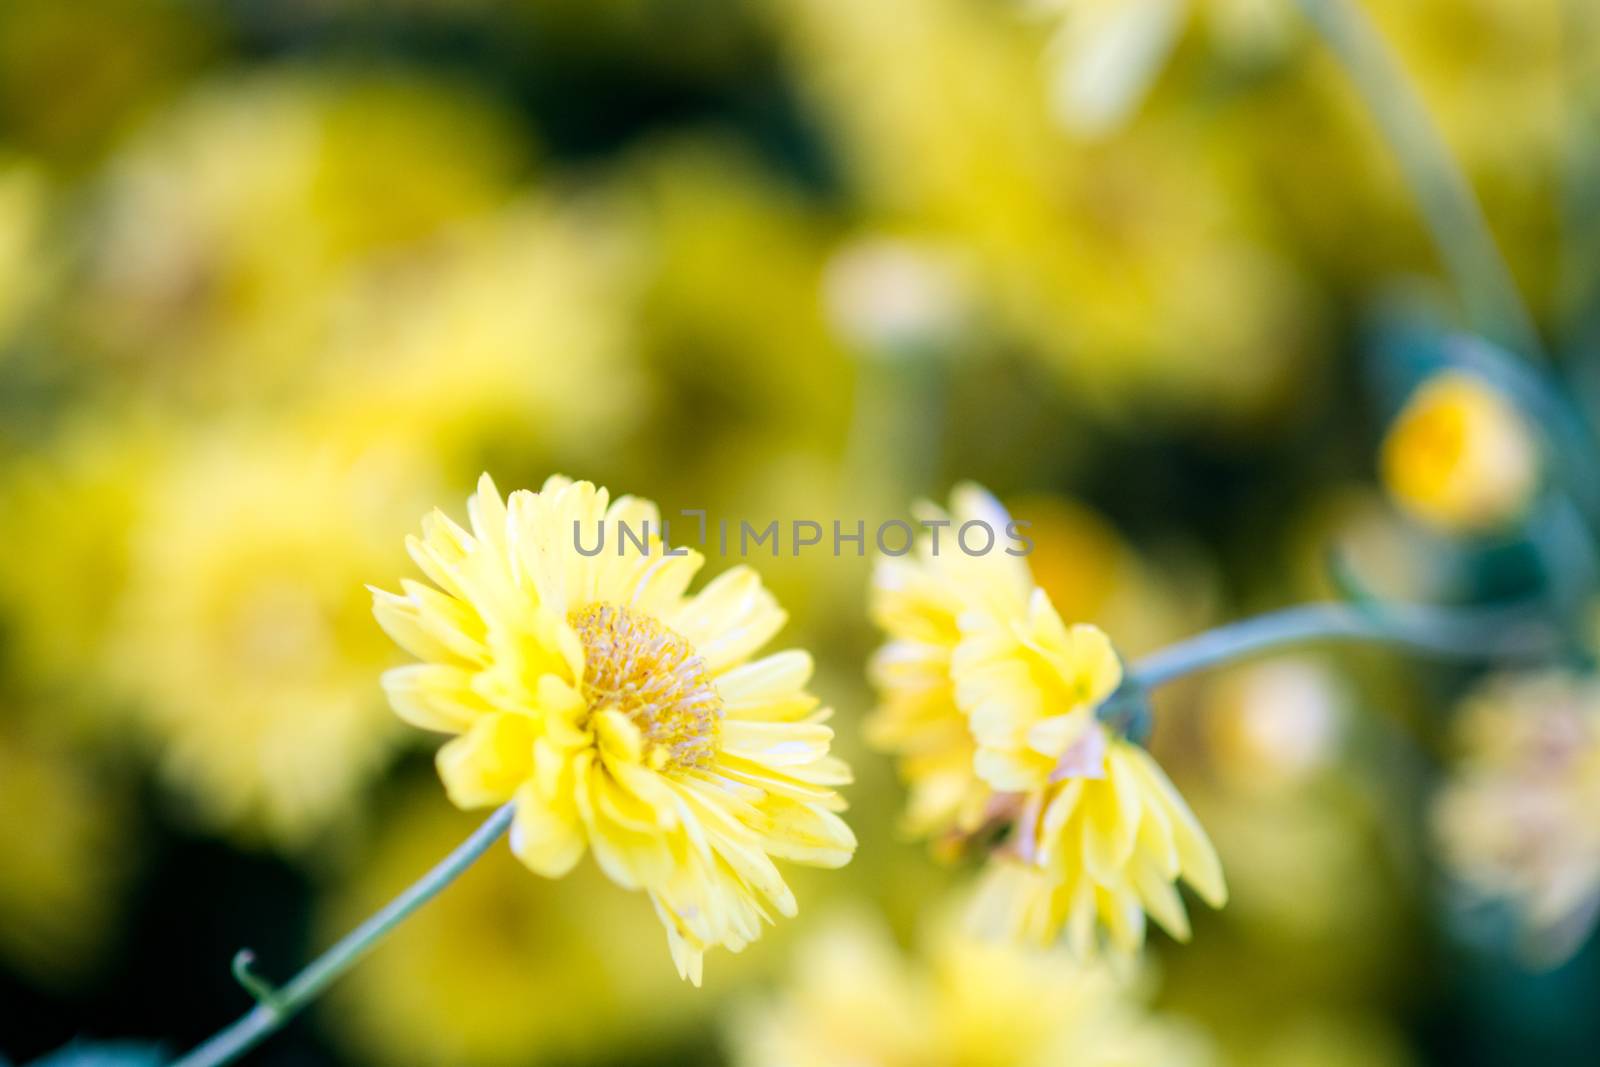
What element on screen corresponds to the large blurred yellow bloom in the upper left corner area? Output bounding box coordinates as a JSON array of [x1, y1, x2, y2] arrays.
[[75, 67, 523, 403]]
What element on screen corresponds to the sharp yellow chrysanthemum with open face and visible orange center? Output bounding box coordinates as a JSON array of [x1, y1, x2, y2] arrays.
[[374, 475, 856, 984]]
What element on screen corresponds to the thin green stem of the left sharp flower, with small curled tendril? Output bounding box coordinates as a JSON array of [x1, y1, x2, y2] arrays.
[[171, 805, 515, 1067]]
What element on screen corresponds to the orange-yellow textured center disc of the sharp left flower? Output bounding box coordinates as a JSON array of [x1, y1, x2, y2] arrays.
[[566, 603, 722, 768]]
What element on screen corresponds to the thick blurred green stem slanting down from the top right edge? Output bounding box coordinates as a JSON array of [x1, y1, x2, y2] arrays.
[[1298, 0, 1541, 357]]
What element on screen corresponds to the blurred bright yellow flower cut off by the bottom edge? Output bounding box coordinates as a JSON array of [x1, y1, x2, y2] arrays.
[[731, 917, 1213, 1067]]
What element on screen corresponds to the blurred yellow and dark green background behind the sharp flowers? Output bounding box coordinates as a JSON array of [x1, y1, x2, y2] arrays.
[[0, 0, 1600, 1067]]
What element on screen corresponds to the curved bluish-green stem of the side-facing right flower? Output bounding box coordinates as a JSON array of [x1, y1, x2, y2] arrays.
[[1128, 603, 1558, 686]]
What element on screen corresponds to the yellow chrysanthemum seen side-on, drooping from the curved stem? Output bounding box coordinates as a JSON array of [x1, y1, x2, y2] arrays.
[[872, 485, 1227, 953]]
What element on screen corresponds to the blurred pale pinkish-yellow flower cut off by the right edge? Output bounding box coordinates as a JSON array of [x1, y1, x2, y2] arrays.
[[1434, 672, 1600, 963]]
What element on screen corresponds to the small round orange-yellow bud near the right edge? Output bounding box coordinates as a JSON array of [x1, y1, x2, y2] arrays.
[[1382, 371, 1539, 531]]
